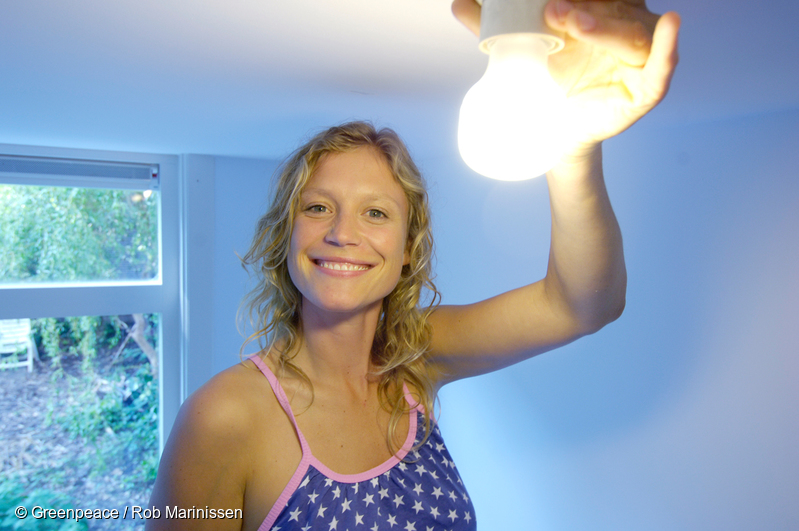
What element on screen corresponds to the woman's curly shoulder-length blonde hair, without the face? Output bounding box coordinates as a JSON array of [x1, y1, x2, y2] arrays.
[[239, 122, 441, 453]]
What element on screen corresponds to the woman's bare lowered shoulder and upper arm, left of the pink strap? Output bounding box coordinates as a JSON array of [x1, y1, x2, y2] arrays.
[[148, 354, 292, 530]]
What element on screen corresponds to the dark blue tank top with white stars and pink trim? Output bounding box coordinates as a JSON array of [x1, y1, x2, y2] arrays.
[[250, 355, 477, 531]]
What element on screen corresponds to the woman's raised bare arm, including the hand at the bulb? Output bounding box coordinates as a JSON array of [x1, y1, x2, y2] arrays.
[[430, 0, 680, 385]]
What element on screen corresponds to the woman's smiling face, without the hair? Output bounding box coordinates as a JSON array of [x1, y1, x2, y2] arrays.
[[288, 147, 409, 318]]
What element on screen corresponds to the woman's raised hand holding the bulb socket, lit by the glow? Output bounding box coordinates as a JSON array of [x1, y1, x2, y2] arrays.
[[452, 0, 680, 147]]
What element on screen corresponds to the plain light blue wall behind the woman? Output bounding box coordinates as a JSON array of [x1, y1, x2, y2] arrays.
[[214, 111, 799, 531]]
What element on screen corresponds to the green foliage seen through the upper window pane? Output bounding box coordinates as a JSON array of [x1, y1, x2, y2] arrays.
[[0, 185, 158, 282]]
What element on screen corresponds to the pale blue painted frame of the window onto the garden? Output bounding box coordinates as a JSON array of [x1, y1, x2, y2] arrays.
[[0, 144, 186, 450]]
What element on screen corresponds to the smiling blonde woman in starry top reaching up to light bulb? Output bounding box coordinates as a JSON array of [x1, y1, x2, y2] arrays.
[[147, 0, 679, 530]]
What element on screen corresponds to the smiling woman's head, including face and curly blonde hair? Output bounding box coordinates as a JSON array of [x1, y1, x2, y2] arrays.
[[238, 122, 438, 454]]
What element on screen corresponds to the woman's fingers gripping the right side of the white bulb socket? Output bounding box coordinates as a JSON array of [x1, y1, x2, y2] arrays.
[[544, 0, 658, 66]]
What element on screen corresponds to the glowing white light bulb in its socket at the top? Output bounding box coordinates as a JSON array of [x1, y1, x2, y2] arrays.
[[458, 0, 568, 181]]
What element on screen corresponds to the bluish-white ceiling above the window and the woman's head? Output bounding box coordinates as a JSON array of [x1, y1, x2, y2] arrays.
[[0, 0, 799, 158]]
